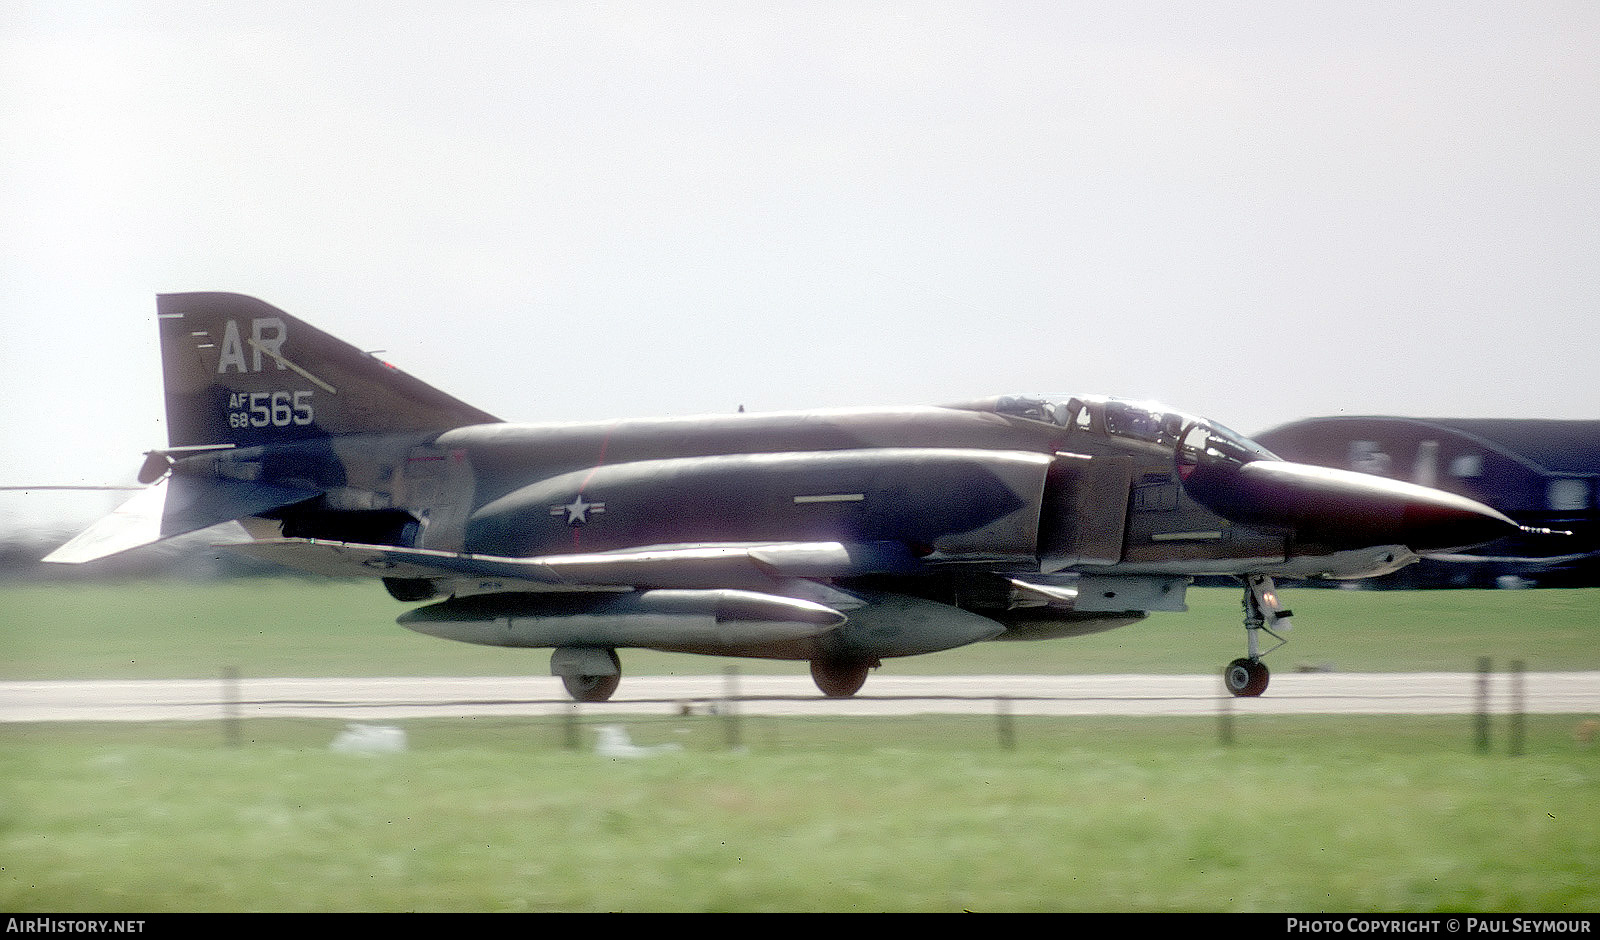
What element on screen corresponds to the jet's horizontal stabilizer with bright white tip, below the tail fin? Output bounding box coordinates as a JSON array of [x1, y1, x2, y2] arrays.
[[45, 476, 320, 564]]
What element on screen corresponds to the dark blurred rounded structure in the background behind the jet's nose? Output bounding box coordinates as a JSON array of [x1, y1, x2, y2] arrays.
[[1256, 416, 1600, 587]]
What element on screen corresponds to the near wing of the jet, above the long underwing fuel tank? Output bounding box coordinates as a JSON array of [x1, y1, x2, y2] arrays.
[[226, 539, 922, 591]]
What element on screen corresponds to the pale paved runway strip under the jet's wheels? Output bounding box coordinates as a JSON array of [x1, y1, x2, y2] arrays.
[[0, 671, 1600, 723]]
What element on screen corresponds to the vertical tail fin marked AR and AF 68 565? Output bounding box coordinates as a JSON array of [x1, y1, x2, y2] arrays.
[[157, 293, 499, 448]]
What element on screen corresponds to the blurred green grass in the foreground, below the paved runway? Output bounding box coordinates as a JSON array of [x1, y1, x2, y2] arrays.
[[0, 718, 1600, 913]]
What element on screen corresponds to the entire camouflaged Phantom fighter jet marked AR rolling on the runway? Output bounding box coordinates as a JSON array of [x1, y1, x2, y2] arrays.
[[48, 293, 1518, 702]]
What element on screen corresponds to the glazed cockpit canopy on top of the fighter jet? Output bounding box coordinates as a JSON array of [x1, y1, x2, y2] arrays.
[[994, 395, 1278, 464]]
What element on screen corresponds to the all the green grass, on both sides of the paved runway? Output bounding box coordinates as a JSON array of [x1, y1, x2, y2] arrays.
[[0, 580, 1600, 913]]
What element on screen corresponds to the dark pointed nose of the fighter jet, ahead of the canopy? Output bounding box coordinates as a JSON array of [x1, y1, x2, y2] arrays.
[[1186, 460, 1520, 553]]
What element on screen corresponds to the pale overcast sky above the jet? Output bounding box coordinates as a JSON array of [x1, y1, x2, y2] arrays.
[[0, 0, 1600, 514]]
